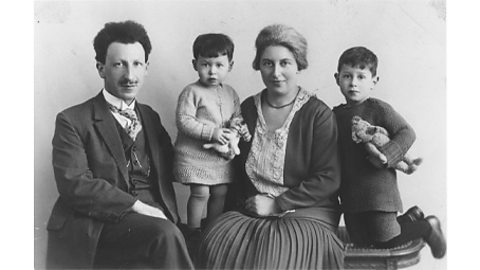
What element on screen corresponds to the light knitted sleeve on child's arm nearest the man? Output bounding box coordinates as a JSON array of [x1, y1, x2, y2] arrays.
[[175, 87, 215, 141]]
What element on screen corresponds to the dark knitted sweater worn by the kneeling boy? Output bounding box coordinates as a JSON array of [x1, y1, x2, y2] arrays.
[[333, 98, 415, 212]]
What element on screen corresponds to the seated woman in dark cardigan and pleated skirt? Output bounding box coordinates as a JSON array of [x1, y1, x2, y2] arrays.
[[197, 25, 344, 269]]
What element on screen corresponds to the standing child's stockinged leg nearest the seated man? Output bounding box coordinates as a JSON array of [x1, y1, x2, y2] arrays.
[[187, 184, 209, 229]]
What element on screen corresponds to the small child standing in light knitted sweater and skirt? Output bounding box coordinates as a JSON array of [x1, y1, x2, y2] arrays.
[[174, 33, 240, 234]]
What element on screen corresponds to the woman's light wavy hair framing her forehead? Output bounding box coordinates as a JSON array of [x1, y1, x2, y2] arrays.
[[252, 24, 308, 70]]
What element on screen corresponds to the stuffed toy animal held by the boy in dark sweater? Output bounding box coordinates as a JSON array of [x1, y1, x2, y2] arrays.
[[352, 116, 422, 174]]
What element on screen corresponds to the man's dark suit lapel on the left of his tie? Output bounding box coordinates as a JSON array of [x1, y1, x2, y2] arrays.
[[93, 92, 128, 186]]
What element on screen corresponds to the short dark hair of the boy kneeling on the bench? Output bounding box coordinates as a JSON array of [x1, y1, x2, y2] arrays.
[[337, 47, 378, 76]]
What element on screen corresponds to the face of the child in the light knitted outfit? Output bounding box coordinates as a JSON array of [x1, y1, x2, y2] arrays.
[[192, 55, 233, 87]]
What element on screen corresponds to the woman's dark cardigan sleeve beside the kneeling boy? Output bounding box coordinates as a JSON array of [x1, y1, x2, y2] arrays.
[[276, 106, 340, 211]]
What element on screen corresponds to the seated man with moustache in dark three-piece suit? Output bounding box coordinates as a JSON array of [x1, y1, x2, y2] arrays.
[[47, 21, 193, 269]]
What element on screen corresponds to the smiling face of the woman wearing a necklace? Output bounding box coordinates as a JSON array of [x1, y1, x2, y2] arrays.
[[260, 45, 298, 95]]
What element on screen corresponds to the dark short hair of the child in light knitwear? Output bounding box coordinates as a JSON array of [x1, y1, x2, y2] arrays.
[[193, 33, 235, 61]]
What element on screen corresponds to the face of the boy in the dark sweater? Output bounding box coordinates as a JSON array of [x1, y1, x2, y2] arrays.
[[335, 65, 378, 104]]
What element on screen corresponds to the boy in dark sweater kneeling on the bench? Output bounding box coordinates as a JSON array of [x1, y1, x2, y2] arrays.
[[333, 47, 446, 258]]
